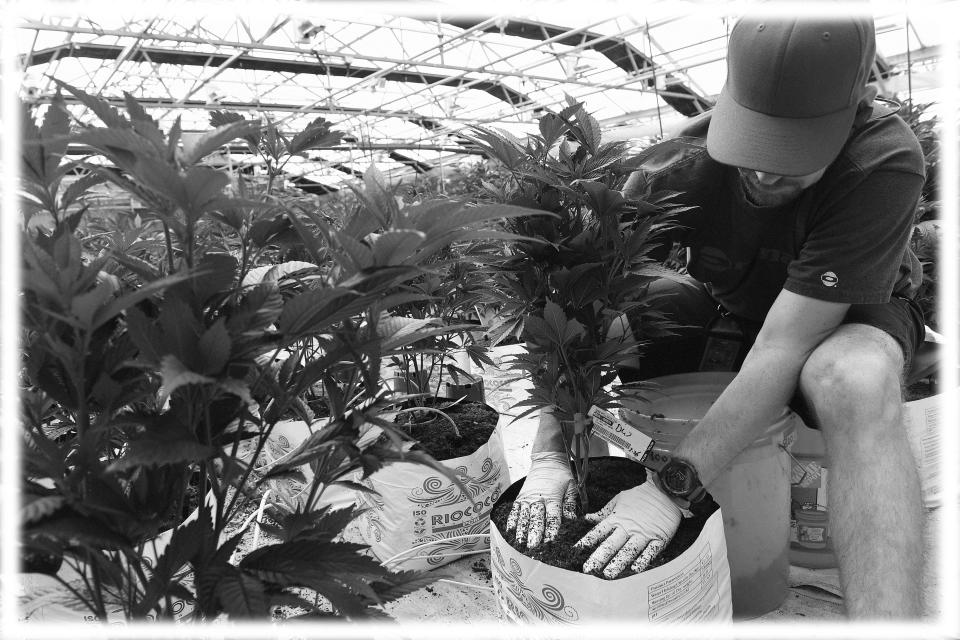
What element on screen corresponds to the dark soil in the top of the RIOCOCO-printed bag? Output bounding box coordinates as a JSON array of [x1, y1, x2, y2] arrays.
[[394, 399, 500, 460]]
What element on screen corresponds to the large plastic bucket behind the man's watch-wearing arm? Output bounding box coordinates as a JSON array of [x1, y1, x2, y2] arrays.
[[621, 372, 796, 619]]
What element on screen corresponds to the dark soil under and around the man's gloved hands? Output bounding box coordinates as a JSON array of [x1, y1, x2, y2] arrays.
[[490, 457, 717, 578]]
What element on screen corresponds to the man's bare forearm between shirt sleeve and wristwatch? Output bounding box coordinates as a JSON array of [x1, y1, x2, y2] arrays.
[[674, 290, 850, 484]]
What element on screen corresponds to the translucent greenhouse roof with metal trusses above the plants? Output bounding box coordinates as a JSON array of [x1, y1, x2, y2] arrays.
[[16, 2, 956, 189]]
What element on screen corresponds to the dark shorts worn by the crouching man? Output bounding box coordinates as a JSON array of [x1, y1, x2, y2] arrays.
[[620, 273, 924, 426]]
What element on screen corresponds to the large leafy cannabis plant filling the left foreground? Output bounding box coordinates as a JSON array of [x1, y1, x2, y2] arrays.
[[21, 83, 540, 619]]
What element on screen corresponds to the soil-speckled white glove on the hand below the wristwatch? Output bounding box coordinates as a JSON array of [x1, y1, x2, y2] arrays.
[[574, 474, 682, 580]]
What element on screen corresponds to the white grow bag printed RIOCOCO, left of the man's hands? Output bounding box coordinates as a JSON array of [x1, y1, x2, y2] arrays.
[[357, 412, 509, 571]]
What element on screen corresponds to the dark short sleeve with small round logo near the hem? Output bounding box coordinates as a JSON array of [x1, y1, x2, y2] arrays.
[[784, 171, 923, 304]]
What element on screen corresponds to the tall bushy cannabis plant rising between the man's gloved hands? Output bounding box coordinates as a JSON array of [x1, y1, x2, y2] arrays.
[[466, 100, 684, 509]]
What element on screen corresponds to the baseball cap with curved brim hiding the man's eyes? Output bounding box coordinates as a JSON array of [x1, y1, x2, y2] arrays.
[[707, 16, 876, 176]]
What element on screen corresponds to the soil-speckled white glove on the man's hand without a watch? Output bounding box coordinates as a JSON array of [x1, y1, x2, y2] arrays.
[[507, 452, 577, 549]]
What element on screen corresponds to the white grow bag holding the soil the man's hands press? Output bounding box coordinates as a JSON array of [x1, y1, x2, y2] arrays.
[[490, 458, 733, 624]]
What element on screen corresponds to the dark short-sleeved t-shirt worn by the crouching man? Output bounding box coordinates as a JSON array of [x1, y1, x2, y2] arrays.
[[624, 103, 924, 322]]
